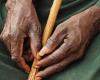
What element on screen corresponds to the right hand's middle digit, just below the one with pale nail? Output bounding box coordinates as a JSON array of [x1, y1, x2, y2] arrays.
[[36, 43, 70, 67]]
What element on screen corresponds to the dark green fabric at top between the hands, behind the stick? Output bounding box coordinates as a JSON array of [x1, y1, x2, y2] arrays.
[[34, 0, 98, 25]]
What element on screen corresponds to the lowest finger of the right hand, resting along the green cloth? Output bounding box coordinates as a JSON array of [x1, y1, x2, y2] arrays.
[[36, 51, 80, 78]]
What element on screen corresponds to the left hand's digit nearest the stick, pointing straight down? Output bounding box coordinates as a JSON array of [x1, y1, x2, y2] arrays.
[[29, 23, 41, 58]]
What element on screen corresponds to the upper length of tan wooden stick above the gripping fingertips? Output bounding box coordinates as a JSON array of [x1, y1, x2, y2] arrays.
[[42, 0, 62, 45]]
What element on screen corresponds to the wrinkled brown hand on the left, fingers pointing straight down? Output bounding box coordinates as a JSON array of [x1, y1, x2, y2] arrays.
[[0, 0, 41, 73]]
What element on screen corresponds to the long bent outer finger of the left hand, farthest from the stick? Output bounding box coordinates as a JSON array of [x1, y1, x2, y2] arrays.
[[11, 38, 30, 73]]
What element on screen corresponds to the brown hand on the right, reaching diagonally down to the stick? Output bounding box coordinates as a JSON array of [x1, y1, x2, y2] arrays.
[[36, 6, 100, 79]]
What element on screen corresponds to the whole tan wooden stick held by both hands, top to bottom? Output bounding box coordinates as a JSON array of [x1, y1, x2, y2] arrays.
[[28, 0, 62, 80]]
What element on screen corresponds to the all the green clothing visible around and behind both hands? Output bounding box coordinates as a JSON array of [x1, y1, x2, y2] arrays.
[[0, 0, 100, 80]]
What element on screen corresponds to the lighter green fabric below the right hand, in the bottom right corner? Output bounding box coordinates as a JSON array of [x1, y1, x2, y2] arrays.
[[47, 35, 100, 80]]
